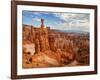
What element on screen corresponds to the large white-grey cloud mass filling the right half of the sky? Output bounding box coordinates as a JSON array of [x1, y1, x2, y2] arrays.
[[53, 13, 89, 32]]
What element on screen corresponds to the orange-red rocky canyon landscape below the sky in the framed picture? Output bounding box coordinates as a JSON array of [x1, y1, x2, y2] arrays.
[[23, 23, 89, 68]]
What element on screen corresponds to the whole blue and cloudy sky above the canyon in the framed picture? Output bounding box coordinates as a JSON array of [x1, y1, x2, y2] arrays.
[[22, 10, 90, 32]]
